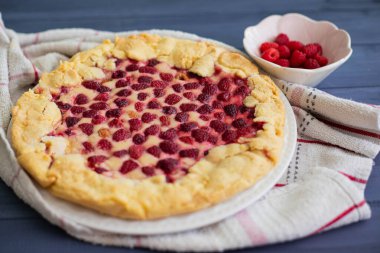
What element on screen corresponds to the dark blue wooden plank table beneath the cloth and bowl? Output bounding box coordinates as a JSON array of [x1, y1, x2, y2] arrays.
[[0, 0, 380, 253]]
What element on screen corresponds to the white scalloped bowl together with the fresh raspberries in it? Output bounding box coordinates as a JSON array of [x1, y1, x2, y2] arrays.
[[243, 13, 352, 87]]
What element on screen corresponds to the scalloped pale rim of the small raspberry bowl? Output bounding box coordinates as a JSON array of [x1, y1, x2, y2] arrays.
[[243, 13, 352, 73]]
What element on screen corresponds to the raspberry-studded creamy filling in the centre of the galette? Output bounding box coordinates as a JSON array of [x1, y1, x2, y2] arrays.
[[51, 59, 263, 182]]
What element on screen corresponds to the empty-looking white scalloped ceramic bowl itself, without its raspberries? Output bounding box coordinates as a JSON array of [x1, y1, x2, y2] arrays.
[[243, 13, 352, 87]]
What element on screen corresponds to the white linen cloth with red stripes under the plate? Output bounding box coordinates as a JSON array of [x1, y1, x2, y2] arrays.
[[0, 17, 380, 251]]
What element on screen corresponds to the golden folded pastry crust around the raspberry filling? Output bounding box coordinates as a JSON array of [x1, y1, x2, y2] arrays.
[[11, 34, 284, 220]]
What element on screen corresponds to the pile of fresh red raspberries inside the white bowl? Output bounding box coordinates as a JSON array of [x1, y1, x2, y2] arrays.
[[260, 33, 328, 69]]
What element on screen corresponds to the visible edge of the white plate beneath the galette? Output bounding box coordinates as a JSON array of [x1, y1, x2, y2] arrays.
[[6, 30, 297, 235]]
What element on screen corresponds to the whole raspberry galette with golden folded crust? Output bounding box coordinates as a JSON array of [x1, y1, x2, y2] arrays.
[[11, 34, 284, 219]]
